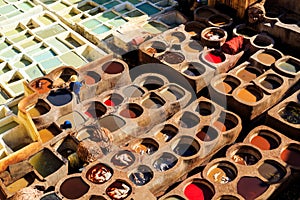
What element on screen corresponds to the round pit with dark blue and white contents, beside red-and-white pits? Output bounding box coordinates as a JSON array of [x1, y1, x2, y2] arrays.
[[129, 165, 153, 186]]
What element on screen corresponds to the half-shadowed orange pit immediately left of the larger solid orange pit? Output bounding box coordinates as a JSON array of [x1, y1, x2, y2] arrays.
[[214, 75, 241, 94]]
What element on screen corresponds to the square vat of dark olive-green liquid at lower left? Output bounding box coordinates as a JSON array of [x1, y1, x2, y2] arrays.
[[29, 149, 64, 178]]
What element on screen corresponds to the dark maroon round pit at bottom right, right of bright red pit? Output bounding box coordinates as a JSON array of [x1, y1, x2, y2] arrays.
[[237, 176, 269, 200]]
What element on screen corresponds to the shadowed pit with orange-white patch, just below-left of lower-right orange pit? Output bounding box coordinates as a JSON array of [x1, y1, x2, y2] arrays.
[[231, 146, 261, 165]]
